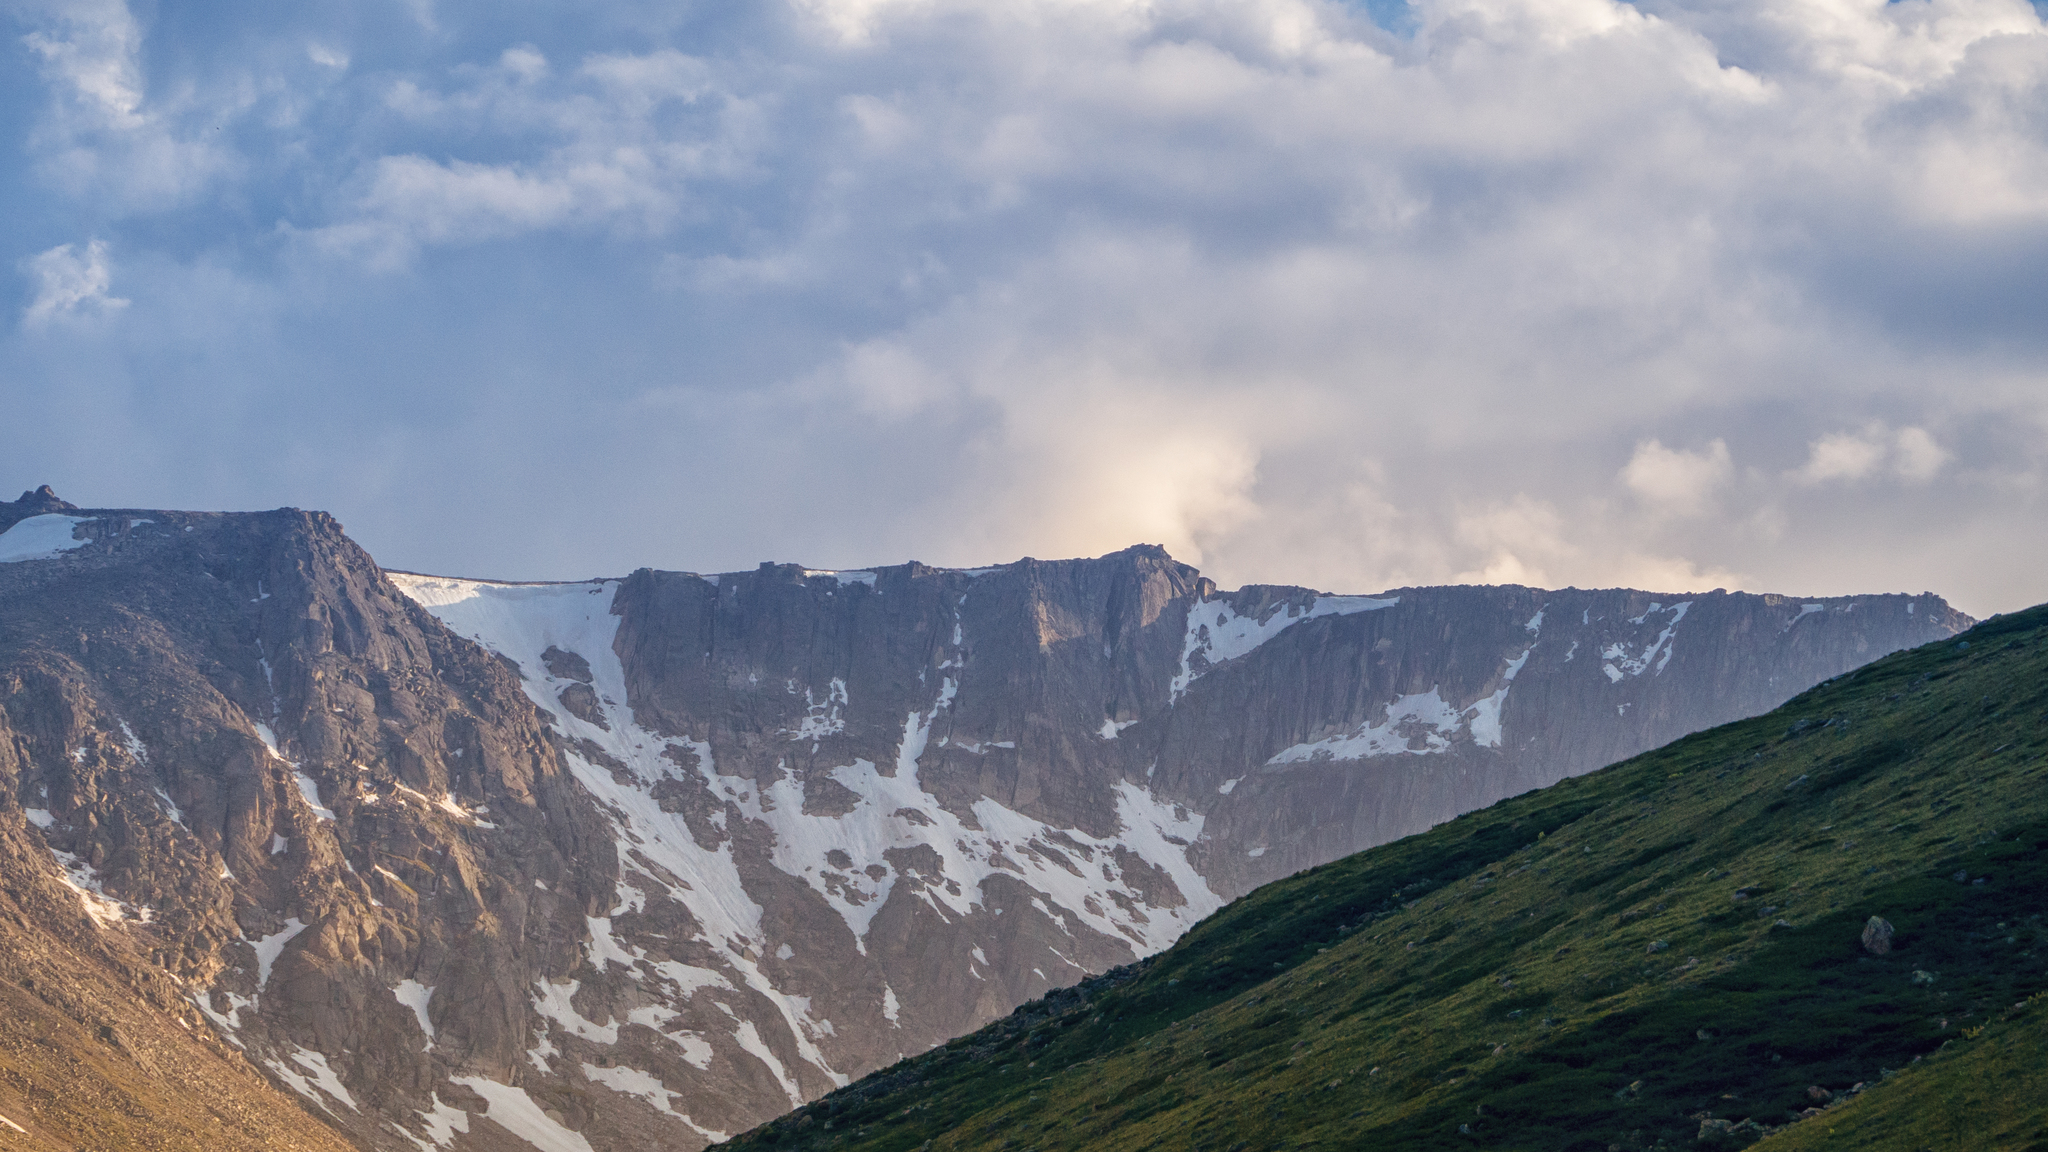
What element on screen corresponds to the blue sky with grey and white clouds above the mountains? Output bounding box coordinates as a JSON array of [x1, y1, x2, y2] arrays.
[[0, 0, 2048, 615]]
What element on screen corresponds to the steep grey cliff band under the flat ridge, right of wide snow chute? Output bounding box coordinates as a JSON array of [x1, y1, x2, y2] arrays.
[[577, 547, 1970, 897]]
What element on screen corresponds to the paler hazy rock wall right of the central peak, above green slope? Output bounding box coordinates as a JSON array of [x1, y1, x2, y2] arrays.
[[1146, 586, 1970, 896]]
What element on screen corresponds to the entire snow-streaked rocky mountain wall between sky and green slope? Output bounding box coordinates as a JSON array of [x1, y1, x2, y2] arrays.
[[0, 490, 1968, 1152]]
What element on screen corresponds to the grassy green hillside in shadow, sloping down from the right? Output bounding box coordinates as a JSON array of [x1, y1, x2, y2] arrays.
[[729, 607, 2048, 1152]]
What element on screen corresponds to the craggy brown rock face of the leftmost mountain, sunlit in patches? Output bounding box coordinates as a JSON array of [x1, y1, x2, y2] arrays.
[[0, 496, 634, 1148]]
